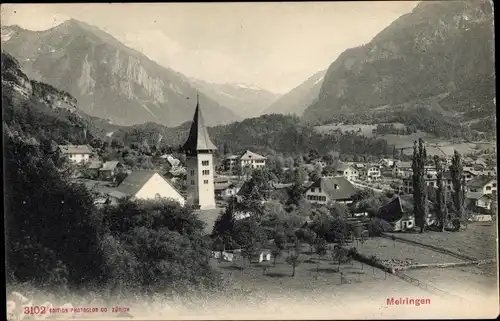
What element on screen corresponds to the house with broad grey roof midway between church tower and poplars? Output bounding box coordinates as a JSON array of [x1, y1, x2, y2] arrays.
[[305, 176, 356, 204]]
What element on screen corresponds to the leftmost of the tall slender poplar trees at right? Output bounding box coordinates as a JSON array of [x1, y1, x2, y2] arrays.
[[412, 138, 427, 233]]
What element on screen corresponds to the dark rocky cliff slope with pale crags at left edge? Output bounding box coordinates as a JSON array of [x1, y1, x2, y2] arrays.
[[1, 51, 105, 144]]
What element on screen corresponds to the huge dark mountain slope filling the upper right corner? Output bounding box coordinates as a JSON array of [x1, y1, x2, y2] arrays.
[[304, 1, 495, 129]]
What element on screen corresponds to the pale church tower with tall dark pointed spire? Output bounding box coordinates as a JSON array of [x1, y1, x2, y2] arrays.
[[182, 95, 217, 210]]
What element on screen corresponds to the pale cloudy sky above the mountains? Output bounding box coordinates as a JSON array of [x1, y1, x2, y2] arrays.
[[1, 1, 417, 93]]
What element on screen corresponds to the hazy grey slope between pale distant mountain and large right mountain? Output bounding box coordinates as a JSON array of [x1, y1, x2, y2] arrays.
[[264, 70, 326, 116]]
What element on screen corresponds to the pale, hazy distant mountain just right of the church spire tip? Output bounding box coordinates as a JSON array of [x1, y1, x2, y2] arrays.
[[191, 79, 281, 118]]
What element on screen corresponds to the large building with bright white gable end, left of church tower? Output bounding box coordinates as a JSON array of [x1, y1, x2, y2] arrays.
[[108, 170, 186, 205]]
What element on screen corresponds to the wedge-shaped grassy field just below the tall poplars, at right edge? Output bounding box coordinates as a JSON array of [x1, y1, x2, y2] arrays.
[[382, 222, 497, 259]]
